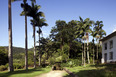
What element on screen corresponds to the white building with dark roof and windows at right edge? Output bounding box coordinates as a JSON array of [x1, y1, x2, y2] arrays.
[[100, 31, 116, 63]]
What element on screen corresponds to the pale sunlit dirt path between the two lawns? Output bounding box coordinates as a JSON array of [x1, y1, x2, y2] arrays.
[[36, 71, 66, 77]]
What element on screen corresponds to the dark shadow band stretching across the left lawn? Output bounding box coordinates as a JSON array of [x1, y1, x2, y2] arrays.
[[0, 68, 43, 77]]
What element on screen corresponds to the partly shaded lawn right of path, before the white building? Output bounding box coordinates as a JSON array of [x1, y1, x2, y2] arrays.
[[64, 64, 116, 77]]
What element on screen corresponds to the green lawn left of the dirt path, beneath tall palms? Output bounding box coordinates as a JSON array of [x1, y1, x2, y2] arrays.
[[0, 67, 51, 77]]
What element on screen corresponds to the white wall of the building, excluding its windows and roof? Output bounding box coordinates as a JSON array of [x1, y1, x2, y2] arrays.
[[101, 36, 116, 63]]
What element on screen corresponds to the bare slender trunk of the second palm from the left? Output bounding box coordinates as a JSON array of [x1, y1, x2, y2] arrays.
[[25, 15, 28, 70]]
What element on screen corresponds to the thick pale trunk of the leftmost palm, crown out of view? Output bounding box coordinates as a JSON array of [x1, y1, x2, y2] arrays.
[[8, 0, 14, 72]]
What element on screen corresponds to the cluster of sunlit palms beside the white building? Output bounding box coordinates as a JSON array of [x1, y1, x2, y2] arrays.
[[76, 17, 106, 66]]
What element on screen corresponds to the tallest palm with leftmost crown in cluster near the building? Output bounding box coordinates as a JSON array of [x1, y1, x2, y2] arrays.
[[76, 17, 92, 63]]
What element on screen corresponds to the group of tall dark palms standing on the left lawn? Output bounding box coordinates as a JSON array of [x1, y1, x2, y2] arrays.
[[8, 0, 48, 71]]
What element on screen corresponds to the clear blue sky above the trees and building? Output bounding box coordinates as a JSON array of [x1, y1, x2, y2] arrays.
[[0, 0, 116, 48]]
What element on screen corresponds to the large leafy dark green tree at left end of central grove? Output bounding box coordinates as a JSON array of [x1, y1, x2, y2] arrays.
[[50, 20, 67, 54]]
